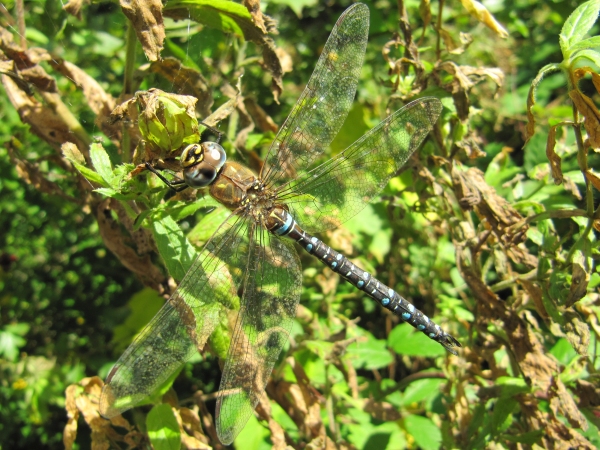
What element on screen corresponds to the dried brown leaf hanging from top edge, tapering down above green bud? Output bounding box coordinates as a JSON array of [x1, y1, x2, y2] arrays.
[[120, 0, 165, 61]]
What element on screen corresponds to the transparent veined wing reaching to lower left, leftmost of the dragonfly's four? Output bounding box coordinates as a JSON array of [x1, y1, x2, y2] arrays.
[[100, 216, 245, 418]]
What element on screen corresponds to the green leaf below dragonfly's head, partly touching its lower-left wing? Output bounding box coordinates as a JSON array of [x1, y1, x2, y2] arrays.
[[150, 216, 197, 280]]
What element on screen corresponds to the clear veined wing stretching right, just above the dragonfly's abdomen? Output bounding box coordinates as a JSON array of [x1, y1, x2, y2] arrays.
[[278, 97, 442, 232]]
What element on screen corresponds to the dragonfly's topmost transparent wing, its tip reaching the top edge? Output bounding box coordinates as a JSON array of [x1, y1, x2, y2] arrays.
[[261, 3, 369, 187]]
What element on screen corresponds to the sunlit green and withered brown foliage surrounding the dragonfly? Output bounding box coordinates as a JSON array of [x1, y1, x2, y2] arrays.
[[0, 0, 600, 449]]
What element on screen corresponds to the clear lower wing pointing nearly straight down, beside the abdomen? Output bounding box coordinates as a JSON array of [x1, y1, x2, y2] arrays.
[[217, 228, 302, 445]]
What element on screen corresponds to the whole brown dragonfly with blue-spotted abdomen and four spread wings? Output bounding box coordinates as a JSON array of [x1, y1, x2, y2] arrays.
[[100, 3, 461, 445]]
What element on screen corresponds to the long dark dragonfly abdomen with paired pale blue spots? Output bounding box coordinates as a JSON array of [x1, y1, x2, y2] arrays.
[[267, 207, 461, 355]]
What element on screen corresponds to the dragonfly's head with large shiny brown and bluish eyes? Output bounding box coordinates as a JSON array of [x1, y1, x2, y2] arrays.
[[181, 142, 227, 189]]
